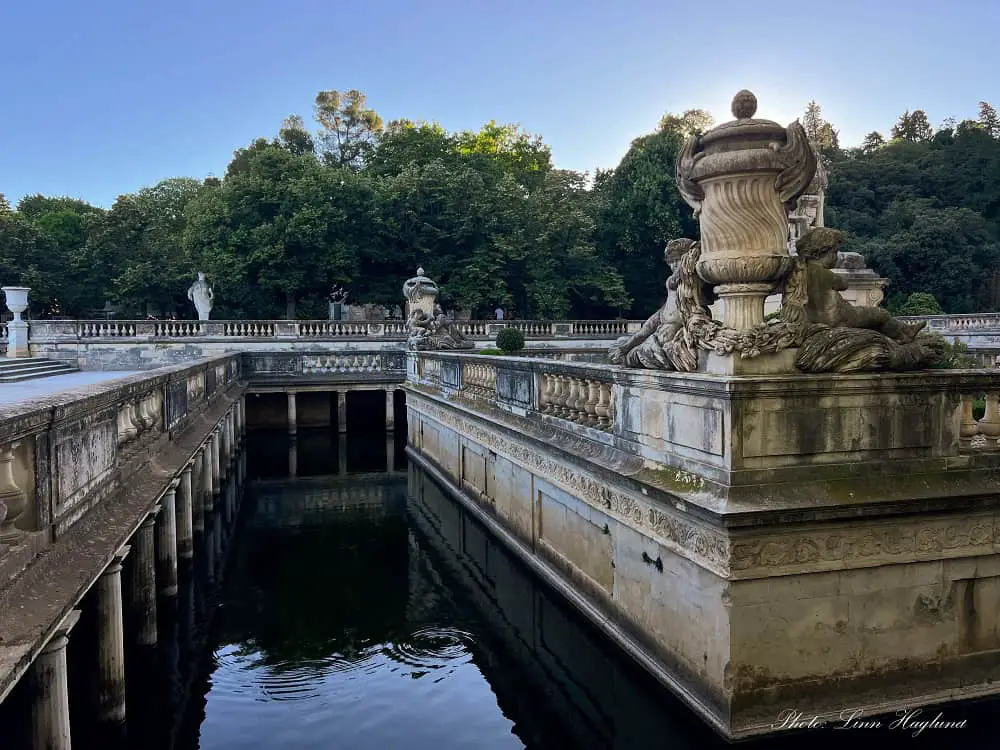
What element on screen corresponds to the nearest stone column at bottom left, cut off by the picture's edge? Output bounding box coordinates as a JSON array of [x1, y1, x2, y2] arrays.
[[28, 609, 80, 750]]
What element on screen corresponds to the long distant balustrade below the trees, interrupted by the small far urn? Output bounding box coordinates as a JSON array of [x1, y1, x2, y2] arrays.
[[30, 320, 642, 342]]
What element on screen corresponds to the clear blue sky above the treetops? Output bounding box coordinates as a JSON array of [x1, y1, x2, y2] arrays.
[[0, 0, 1000, 206]]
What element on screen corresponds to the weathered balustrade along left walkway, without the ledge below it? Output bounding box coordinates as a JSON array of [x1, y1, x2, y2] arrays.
[[0, 355, 243, 587]]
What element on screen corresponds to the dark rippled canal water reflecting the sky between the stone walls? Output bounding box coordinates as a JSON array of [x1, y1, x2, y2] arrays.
[[7, 431, 1000, 750]]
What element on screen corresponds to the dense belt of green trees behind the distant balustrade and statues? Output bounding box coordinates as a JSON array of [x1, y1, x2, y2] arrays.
[[0, 91, 1000, 318]]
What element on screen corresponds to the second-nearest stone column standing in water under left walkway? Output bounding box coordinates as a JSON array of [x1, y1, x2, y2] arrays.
[[95, 547, 129, 722]]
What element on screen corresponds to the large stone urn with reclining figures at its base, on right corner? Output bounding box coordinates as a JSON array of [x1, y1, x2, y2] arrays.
[[609, 91, 943, 374]]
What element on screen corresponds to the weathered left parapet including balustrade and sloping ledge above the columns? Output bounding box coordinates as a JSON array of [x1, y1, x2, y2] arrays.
[[0, 355, 244, 700]]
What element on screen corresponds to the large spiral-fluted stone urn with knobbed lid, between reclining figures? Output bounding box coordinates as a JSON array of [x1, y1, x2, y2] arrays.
[[677, 91, 816, 330]]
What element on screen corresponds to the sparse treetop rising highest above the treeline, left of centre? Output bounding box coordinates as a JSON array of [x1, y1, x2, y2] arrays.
[[315, 89, 382, 170]]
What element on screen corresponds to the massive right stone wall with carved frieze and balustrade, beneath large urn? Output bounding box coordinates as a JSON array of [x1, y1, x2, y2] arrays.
[[406, 353, 1000, 737]]
